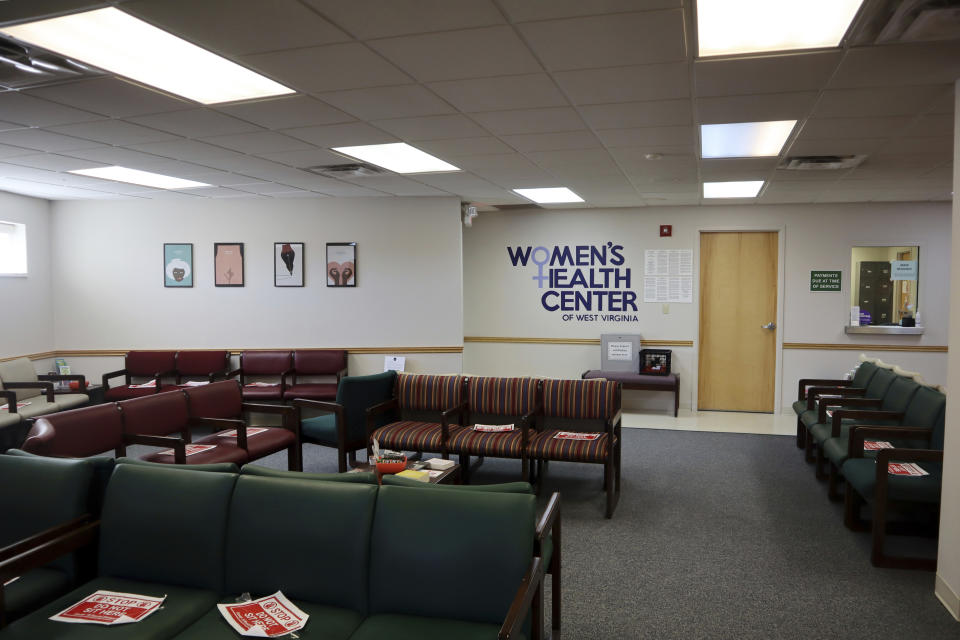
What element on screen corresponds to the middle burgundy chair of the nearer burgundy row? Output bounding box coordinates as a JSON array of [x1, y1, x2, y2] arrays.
[[119, 387, 247, 465]]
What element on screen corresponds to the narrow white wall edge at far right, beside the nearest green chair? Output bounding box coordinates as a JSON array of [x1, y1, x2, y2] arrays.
[[936, 80, 960, 620]]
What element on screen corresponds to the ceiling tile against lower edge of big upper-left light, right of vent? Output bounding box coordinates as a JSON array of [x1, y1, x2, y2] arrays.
[[24, 78, 196, 118]]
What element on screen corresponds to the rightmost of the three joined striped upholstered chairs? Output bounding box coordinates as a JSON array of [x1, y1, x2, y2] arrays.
[[527, 379, 621, 518]]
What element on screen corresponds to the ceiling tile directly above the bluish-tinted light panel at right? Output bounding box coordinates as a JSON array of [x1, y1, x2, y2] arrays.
[[696, 91, 817, 124]]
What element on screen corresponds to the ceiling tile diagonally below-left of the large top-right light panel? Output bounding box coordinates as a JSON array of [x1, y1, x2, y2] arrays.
[[554, 62, 690, 104]]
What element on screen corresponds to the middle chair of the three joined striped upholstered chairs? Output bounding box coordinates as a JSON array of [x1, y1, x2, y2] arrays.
[[447, 378, 541, 482]]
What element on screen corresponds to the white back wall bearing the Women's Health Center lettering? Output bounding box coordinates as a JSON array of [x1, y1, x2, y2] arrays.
[[464, 203, 950, 408]]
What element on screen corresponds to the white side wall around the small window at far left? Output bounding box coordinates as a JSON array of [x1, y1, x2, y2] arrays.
[[0, 192, 54, 358]]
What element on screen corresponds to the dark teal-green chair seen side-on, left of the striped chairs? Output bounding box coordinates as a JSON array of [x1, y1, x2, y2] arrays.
[[293, 371, 397, 473]]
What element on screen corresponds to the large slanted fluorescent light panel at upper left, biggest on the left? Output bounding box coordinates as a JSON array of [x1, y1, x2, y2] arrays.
[[0, 7, 294, 104]]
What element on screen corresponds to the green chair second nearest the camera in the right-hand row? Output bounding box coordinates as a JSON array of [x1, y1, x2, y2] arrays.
[[821, 385, 947, 499]]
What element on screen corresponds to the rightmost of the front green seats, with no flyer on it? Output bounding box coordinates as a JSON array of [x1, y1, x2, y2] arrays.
[[351, 486, 542, 640]]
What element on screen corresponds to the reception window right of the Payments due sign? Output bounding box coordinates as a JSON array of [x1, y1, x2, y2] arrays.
[[850, 246, 920, 325]]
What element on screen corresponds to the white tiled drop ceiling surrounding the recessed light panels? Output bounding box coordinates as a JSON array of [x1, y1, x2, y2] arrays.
[[0, 0, 960, 208]]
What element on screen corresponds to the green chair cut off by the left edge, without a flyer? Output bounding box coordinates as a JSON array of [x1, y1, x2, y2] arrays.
[[0, 455, 94, 624]]
